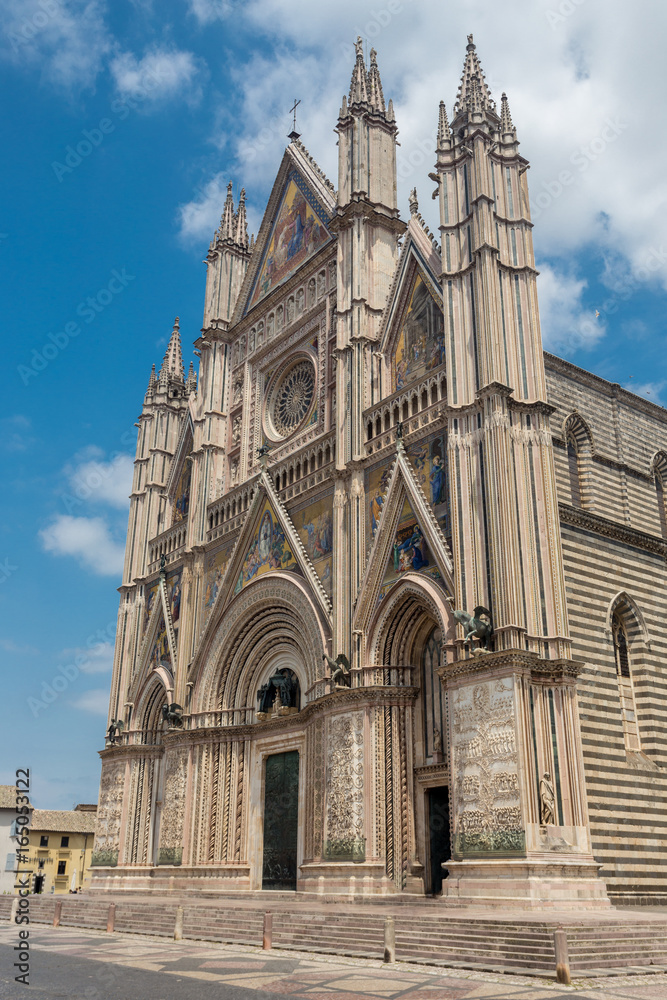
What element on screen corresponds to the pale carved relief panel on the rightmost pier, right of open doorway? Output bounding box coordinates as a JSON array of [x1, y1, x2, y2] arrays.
[[451, 678, 525, 856]]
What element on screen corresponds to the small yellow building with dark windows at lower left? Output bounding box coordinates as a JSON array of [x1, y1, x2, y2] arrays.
[[27, 805, 97, 893]]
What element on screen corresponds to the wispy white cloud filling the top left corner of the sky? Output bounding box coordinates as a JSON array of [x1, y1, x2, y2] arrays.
[[0, 0, 112, 89]]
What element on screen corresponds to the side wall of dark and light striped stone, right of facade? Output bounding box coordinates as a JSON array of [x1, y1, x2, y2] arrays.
[[545, 355, 667, 903]]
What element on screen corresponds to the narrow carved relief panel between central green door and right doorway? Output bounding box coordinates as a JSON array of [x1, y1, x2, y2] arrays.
[[324, 712, 366, 861]]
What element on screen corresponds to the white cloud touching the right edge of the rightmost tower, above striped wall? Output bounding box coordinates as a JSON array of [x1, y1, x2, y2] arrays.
[[537, 265, 606, 355]]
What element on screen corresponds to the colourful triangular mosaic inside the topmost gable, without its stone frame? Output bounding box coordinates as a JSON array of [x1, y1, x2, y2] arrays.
[[247, 170, 331, 309]]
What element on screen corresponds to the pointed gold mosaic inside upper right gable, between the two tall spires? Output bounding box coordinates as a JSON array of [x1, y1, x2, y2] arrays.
[[391, 273, 445, 392]]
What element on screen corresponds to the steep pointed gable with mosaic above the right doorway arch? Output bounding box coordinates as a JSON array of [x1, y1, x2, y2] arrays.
[[354, 442, 454, 630]]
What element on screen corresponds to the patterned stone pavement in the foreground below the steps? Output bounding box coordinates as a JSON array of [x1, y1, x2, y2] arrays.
[[0, 924, 667, 1000]]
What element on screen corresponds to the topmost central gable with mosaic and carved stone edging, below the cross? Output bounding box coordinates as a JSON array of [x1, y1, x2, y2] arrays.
[[232, 141, 335, 324]]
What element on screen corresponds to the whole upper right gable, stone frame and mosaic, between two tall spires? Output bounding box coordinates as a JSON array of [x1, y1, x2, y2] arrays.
[[381, 225, 445, 395]]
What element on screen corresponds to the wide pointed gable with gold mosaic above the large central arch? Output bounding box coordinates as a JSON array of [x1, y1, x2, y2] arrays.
[[201, 471, 332, 656]]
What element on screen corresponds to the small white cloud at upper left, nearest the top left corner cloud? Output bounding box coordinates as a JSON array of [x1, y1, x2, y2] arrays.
[[110, 46, 201, 103]]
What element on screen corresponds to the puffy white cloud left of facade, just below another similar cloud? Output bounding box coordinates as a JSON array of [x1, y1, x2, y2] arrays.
[[39, 514, 125, 576]]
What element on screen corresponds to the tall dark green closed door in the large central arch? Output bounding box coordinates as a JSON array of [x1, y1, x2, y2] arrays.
[[262, 750, 299, 890]]
